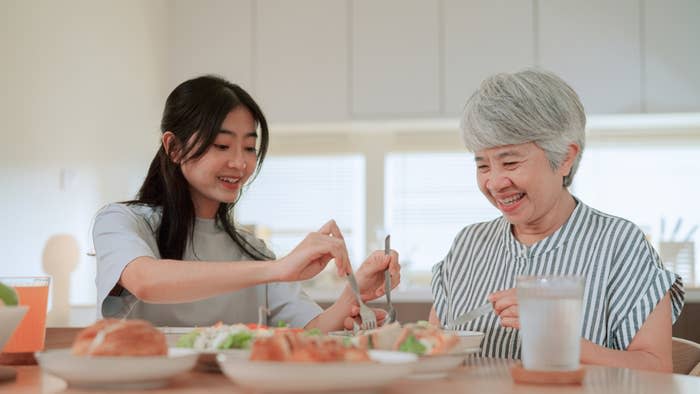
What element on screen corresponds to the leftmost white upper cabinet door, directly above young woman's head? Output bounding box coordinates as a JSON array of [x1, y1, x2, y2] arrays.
[[167, 0, 254, 90]]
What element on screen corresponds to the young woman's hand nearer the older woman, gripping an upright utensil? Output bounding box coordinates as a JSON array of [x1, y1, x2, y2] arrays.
[[355, 250, 401, 301]]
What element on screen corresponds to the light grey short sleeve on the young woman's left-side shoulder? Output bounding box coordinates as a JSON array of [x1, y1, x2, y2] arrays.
[[92, 204, 157, 317]]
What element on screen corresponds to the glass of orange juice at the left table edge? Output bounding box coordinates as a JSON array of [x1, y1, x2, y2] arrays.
[[0, 276, 51, 353]]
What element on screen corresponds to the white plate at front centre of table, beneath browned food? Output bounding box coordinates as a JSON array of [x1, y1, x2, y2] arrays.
[[216, 350, 417, 392]]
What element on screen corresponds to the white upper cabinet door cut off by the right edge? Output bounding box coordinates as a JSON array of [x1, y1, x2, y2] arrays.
[[644, 0, 700, 112]]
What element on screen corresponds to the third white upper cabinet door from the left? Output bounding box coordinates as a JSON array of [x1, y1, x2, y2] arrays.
[[351, 0, 440, 118]]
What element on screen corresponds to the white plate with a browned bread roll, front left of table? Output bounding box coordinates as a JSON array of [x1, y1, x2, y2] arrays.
[[35, 319, 198, 389]]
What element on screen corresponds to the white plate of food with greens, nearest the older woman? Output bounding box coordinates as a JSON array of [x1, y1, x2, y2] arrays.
[[331, 321, 484, 379]]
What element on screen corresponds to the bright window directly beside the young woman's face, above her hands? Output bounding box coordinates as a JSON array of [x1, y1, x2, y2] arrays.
[[236, 155, 365, 268]]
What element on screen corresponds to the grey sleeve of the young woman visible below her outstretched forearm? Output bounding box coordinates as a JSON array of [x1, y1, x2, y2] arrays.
[[267, 282, 323, 328]]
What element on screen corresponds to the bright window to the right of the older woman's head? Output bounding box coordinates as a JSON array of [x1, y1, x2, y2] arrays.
[[572, 140, 700, 285]]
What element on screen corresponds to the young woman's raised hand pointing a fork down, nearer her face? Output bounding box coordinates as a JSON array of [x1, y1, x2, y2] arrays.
[[275, 220, 351, 282]]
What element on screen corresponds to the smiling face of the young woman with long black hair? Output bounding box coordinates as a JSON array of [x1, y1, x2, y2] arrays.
[[171, 105, 257, 218]]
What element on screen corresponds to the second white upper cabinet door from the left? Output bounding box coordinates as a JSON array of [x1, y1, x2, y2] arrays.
[[253, 0, 350, 123]]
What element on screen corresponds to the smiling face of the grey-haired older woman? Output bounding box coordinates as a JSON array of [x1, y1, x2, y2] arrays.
[[475, 142, 578, 243]]
